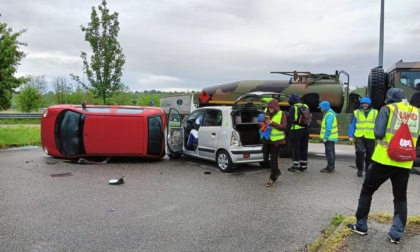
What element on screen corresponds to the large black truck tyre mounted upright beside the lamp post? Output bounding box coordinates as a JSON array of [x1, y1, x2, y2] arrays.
[[367, 67, 388, 109]]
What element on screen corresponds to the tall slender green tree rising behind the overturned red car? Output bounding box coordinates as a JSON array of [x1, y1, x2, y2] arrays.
[[71, 0, 125, 104]]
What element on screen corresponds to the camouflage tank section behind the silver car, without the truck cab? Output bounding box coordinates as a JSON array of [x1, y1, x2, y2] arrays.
[[198, 71, 365, 156]]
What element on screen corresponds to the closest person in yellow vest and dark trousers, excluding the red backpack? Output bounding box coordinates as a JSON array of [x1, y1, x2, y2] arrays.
[[347, 88, 420, 244]]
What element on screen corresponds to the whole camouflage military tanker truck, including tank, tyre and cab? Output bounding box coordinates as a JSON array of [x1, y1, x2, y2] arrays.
[[198, 61, 420, 156]]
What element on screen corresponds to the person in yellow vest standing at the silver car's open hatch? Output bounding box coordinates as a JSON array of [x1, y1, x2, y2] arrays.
[[262, 99, 287, 187]]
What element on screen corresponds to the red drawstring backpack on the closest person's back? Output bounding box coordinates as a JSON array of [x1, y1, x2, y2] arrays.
[[388, 109, 416, 162]]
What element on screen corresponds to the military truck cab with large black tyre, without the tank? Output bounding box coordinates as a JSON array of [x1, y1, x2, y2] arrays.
[[366, 60, 420, 109]]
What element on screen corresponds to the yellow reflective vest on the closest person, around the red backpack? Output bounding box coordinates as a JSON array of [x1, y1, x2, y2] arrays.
[[372, 102, 420, 169]]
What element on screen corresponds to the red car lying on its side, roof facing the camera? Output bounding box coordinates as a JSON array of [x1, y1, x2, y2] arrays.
[[41, 105, 167, 159]]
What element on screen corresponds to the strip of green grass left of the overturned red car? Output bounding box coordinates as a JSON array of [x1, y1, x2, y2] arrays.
[[0, 125, 41, 148]]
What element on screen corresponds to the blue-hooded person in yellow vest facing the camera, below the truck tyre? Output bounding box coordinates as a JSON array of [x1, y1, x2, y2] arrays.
[[349, 97, 378, 177]]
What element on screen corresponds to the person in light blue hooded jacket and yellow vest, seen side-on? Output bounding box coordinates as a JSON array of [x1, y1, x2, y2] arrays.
[[319, 101, 338, 173]]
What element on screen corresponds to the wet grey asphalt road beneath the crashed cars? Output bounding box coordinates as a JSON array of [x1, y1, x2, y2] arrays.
[[0, 144, 420, 251]]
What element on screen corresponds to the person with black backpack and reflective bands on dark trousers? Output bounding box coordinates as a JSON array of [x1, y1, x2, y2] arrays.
[[287, 94, 309, 172]]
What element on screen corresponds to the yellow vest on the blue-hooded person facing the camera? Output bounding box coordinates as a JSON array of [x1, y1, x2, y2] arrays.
[[354, 109, 378, 139]]
